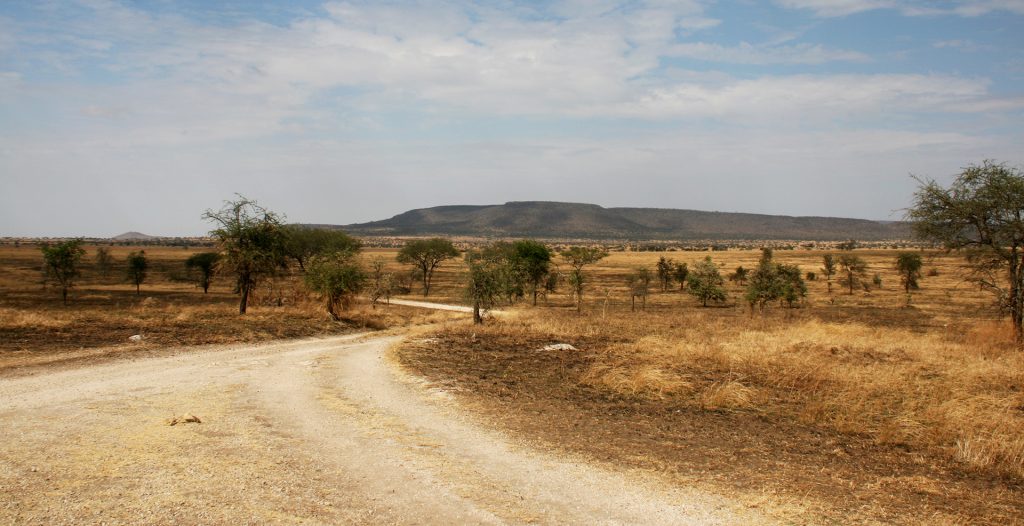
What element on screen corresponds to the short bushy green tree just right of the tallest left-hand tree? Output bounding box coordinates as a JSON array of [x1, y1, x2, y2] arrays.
[[303, 250, 367, 320]]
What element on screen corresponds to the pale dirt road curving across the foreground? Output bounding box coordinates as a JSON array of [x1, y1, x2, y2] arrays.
[[0, 335, 757, 524]]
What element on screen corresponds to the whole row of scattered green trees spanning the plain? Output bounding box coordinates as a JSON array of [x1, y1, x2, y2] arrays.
[[32, 161, 1024, 344]]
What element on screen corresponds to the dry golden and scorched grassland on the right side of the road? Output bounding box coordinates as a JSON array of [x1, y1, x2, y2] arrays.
[[399, 250, 1024, 524]]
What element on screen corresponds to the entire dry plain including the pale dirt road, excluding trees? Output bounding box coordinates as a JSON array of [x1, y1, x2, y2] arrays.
[[0, 244, 1024, 524]]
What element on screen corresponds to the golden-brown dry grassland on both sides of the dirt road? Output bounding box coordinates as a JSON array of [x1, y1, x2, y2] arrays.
[[0, 240, 1024, 524]]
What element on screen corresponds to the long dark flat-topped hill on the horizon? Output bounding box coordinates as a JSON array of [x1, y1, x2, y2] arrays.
[[333, 201, 910, 240]]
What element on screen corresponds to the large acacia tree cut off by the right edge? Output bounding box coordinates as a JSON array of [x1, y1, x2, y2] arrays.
[[907, 161, 1024, 345]]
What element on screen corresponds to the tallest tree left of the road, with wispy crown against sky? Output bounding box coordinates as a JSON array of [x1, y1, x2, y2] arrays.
[[203, 195, 285, 314]]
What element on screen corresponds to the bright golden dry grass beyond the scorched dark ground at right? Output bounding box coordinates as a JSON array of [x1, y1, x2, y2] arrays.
[[474, 309, 1024, 479]]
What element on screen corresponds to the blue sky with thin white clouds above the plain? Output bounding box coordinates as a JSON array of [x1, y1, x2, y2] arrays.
[[0, 0, 1024, 236]]
